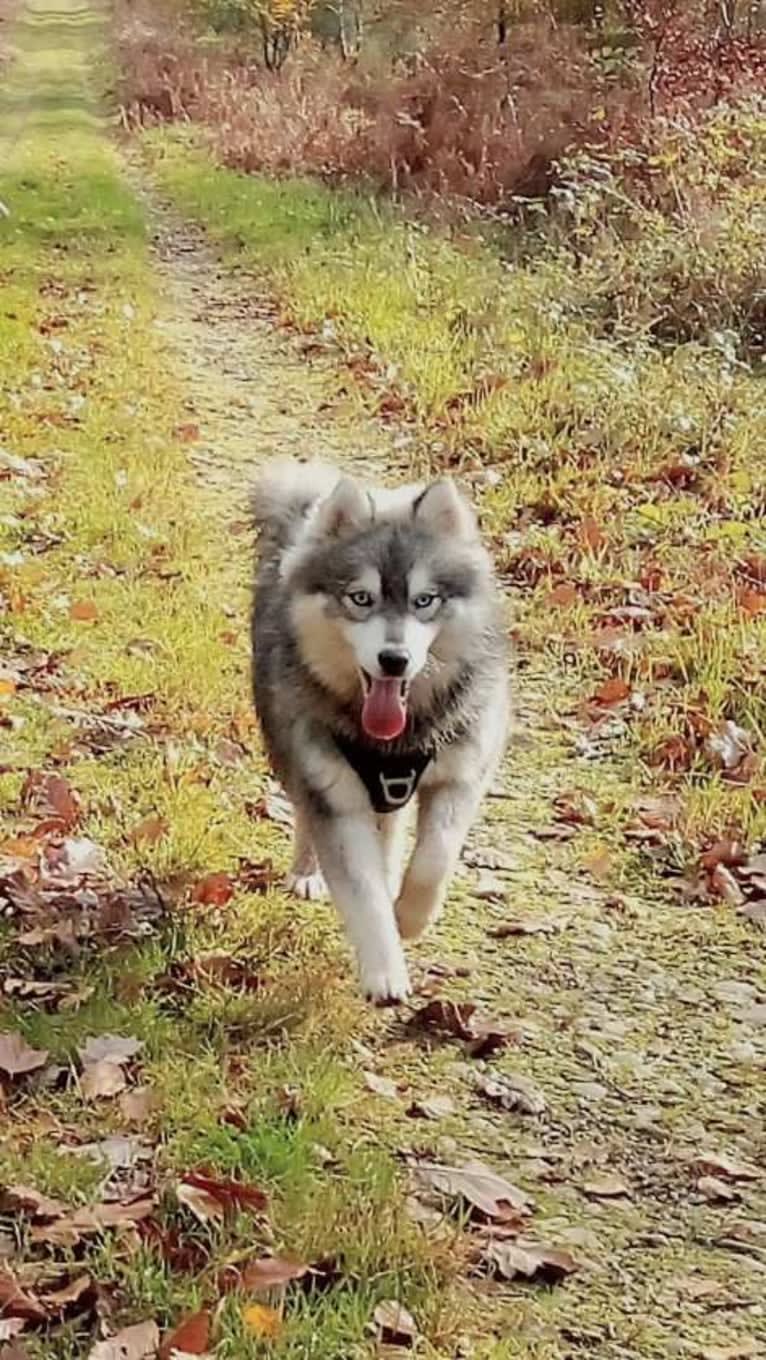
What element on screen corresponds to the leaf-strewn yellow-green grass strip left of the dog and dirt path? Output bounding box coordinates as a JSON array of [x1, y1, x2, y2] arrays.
[[0, 0, 448, 1360]]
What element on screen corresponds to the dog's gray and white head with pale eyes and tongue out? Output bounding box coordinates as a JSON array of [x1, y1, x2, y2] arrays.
[[286, 477, 490, 741]]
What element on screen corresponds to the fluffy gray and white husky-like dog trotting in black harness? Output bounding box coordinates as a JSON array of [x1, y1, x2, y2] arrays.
[[253, 461, 509, 1004]]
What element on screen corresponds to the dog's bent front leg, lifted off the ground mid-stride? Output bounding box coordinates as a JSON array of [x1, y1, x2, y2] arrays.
[[396, 783, 482, 940]]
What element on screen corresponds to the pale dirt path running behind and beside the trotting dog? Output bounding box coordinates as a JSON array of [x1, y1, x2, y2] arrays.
[[128, 172, 766, 1357]]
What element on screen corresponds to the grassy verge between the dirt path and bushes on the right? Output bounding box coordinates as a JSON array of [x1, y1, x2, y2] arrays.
[[146, 119, 766, 851]]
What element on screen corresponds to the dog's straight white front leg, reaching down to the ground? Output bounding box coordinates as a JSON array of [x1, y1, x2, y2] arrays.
[[310, 813, 410, 1005]]
